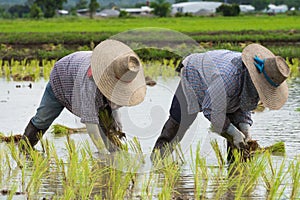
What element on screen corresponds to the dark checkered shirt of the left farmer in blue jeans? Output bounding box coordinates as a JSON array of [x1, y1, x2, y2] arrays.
[[50, 51, 104, 124]]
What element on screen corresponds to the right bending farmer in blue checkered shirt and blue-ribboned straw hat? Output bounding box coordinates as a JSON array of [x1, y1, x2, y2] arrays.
[[152, 44, 290, 158]]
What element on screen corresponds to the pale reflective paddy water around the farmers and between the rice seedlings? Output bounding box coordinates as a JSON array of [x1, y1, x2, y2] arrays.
[[0, 77, 300, 199]]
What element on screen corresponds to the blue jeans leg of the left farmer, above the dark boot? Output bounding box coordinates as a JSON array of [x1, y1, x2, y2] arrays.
[[31, 83, 64, 130]]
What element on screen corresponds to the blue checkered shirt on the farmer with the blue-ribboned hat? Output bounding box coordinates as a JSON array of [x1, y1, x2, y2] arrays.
[[181, 50, 252, 133]]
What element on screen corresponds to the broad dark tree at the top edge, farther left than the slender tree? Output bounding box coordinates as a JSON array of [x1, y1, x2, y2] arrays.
[[35, 0, 67, 18]]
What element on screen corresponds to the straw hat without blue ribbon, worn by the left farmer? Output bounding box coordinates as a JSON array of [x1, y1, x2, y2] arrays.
[[91, 40, 146, 106]]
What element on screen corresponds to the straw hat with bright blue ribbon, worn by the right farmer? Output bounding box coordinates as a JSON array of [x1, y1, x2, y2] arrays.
[[242, 44, 290, 110]]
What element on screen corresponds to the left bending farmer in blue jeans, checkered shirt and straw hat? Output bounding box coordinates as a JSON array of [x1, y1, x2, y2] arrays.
[[22, 40, 146, 150]]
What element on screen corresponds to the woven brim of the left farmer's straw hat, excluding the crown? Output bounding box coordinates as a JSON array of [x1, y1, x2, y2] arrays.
[[91, 40, 146, 106]]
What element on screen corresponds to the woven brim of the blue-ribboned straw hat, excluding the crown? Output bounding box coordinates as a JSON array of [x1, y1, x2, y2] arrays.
[[242, 44, 288, 110]]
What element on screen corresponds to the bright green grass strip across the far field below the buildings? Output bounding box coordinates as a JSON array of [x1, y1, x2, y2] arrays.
[[0, 15, 300, 33]]
